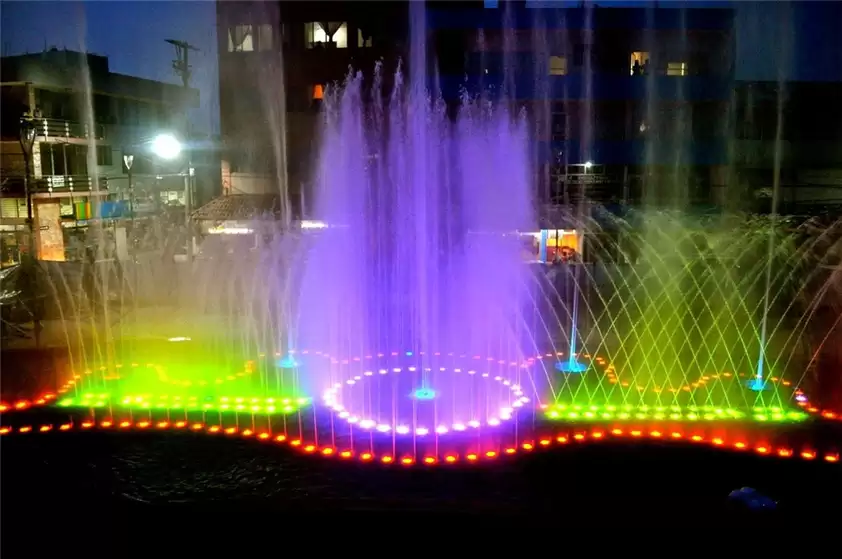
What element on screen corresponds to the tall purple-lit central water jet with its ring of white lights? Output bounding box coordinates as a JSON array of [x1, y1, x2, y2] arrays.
[[296, 10, 534, 434]]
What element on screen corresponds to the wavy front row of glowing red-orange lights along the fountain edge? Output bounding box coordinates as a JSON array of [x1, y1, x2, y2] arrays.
[[0, 420, 839, 466]]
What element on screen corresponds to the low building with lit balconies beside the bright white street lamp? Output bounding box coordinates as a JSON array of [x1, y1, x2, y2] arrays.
[[0, 49, 199, 262]]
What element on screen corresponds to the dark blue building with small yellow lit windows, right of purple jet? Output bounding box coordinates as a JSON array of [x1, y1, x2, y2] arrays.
[[428, 2, 735, 209]]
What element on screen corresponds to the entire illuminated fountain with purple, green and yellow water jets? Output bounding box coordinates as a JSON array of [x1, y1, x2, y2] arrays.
[[0, 3, 838, 465]]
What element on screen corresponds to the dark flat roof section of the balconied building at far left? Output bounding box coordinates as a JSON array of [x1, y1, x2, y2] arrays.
[[0, 48, 199, 107]]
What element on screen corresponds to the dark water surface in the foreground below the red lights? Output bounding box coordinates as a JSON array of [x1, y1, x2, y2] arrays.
[[2, 432, 842, 557]]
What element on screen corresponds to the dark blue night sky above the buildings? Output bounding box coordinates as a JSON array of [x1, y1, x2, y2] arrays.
[[0, 0, 842, 133]]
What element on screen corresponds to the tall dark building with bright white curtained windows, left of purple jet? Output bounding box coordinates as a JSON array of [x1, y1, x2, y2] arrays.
[[217, 1, 408, 208]]
